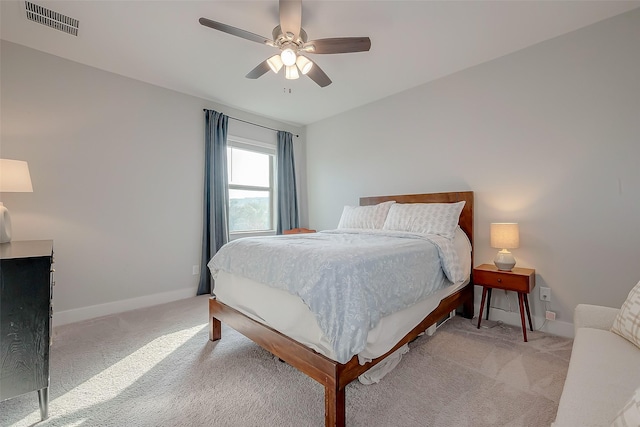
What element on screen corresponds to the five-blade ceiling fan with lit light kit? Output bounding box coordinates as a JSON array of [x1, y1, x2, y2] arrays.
[[200, 0, 371, 87]]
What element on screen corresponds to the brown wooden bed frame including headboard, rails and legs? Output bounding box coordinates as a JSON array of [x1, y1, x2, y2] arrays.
[[209, 191, 473, 427]]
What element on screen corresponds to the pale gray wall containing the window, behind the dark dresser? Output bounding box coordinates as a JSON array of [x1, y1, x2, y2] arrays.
[[0, 41, 307, 324]]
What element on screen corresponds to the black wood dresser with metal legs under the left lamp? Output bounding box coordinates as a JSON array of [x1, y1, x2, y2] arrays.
[[0, 240, 53, 420]]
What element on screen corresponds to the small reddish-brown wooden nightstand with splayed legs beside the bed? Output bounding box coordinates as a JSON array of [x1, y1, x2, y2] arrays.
[[473, 264, 536, 342]]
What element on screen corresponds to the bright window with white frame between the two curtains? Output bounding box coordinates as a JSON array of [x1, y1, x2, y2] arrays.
[[227, 136, 275, 233]]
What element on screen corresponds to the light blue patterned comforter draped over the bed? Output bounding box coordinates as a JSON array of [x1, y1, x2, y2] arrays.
[[208, 229, 464, 363]]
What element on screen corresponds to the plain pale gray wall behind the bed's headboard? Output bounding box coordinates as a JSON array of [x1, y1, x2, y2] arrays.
[[307, 10, 640, 334]]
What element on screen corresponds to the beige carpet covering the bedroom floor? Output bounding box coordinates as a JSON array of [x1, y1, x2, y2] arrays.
[[0, 296, 572, 427]]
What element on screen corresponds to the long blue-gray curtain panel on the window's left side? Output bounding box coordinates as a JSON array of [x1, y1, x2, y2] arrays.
[[198, 110, 229, 295]]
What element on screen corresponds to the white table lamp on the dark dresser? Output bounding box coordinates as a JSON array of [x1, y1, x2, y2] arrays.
[[0, 159, 33, 243]]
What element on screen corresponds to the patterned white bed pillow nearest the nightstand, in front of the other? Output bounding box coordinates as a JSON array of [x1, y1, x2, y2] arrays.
[[382, 202, 465, 240]]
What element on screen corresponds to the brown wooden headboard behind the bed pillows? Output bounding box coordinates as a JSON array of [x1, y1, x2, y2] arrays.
[[360, 191, 474, 265]]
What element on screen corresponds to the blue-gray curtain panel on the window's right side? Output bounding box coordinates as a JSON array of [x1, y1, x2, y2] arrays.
[[276, 130, 300, 234]]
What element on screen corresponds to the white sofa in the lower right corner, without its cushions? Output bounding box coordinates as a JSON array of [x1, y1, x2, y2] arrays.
[[552, 304, 640, 427]]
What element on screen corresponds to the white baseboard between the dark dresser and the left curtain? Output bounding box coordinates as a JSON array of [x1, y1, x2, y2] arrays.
[[53, 288, 196, 327]]
